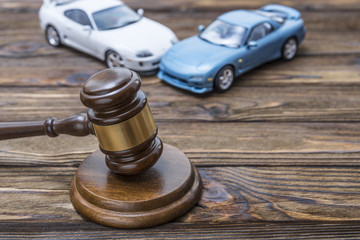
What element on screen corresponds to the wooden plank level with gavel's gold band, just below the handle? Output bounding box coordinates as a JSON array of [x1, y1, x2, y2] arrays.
[[0, 122, 360, 166]]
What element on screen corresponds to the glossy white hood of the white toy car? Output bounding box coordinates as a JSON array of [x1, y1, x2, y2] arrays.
[[99, 17, 176, 55]]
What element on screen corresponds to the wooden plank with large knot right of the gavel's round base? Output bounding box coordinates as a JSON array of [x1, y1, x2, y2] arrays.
[[0, 166, 360, 224]]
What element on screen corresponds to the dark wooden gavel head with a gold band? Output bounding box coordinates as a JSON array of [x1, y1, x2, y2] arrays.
[[80, 68, 163, 175]]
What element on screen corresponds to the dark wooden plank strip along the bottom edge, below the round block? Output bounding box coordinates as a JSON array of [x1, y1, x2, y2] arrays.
[[0, 221, 359, 239]]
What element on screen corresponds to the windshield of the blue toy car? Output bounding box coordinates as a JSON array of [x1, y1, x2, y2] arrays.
[[200, 19, 246, 48]]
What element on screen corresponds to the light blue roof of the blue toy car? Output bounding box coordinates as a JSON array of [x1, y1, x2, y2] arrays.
[[218, 10, 270, 28]]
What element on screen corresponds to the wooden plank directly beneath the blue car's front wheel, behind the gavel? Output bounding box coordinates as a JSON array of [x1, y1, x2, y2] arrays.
[[0, 84, 360, 122]]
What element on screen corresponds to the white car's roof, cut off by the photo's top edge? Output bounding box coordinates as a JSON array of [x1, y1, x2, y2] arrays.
[[60, 0, 123, 13]]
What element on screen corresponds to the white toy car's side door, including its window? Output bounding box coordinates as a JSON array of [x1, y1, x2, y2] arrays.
[[64, 9, 95, 55]]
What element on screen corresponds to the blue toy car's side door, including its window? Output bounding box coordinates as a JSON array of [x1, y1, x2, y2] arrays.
[[245, 22, 277, 69]]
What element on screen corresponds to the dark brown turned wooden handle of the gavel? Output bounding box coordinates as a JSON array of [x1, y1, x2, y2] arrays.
[[0, 113, 94, 140]]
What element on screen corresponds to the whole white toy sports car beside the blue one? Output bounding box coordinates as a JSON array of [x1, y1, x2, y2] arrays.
[[39, 0, 178, 73]]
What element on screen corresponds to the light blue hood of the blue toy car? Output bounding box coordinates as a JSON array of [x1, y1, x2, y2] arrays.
[[162, 36, 235, 71]]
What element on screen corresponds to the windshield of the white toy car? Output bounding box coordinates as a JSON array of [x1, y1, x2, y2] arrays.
[[92, 5, 141, 31]]
